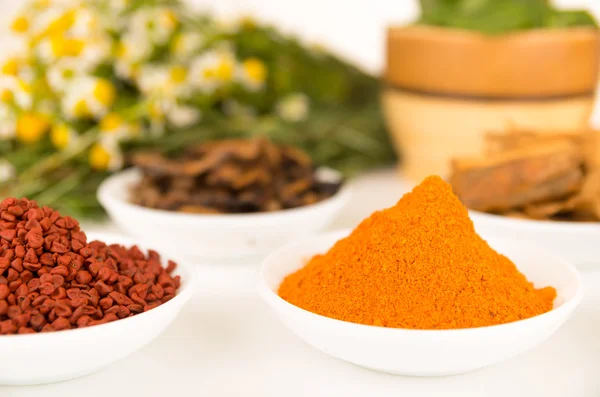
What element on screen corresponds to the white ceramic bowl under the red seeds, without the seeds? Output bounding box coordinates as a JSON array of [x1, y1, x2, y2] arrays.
[[0, 233, 196, 385]]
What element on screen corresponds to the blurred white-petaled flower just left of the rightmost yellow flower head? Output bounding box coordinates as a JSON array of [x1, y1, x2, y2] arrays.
[[190, 50, 236, 94]]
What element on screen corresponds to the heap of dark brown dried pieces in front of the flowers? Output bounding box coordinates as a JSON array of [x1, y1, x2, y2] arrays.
[[131, 138, 341, 214]]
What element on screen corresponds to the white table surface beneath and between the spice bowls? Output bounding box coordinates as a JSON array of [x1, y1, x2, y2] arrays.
[[0, 170, 600, 397]]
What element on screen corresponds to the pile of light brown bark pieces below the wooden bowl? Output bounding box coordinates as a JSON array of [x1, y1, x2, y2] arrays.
[[451, 131, 600, 221]]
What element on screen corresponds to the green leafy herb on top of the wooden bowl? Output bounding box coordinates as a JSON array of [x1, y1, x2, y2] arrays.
[[419, 0, 597, 34]]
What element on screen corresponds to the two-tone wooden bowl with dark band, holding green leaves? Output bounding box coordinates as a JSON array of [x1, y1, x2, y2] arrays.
[[382, 26, 600, 180]]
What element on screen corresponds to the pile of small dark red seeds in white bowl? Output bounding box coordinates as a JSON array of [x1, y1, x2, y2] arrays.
[[0, 198, 180, 335]]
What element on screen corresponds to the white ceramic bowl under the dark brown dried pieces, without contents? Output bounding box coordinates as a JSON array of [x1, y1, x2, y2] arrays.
[[98, 169, 350, 258]]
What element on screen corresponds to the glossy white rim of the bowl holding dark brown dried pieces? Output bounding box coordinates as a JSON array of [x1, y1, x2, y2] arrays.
[[97, 168, 352, 224]]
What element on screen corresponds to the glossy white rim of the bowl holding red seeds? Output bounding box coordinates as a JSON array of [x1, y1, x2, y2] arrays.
[[0, 233, 198, 340]]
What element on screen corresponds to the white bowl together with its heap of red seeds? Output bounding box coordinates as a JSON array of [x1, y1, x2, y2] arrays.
[[0, 198, 195, 385]]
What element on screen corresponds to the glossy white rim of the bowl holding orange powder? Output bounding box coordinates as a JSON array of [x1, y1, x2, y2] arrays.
[[256, 230, 583, 338]]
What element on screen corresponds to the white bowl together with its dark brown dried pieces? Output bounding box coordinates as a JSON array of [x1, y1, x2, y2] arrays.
[[98, 139, 350, 258]]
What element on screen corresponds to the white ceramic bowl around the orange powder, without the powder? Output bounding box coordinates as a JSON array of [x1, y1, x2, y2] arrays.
[[258, 231, 583, 376]]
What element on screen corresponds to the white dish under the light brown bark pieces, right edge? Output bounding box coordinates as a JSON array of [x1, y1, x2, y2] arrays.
[[470, 211, 600, 269]]
